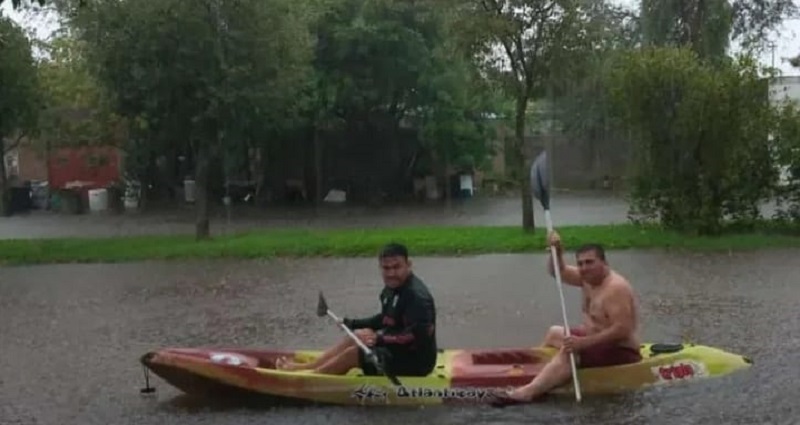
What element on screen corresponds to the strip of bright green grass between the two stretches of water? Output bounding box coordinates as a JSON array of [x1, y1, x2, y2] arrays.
[[0, 224, 800, 264]]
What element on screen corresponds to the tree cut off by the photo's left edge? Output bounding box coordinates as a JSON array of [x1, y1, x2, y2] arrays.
[[0, 16, 40, 213]]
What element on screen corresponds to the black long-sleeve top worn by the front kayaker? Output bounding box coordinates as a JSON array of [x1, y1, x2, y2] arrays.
[[344, 273, 437, 361]]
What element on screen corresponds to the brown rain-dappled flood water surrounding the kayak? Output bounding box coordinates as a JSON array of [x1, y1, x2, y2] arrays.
[[0, 251, 800, 425]]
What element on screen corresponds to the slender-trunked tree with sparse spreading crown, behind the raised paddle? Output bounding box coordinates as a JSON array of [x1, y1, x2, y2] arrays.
[[455, 0, 628, 231]]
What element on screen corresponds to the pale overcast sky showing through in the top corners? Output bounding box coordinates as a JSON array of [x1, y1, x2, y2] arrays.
[[0, 0, 800, 76]]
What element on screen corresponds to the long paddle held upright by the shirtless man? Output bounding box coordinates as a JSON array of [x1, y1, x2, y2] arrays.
[[530, 151, 581, 402]]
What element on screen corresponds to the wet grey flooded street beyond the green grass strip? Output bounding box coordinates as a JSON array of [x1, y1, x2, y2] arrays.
[[0, 193, 648, 239]]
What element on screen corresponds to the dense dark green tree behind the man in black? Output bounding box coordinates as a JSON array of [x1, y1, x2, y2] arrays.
[[308, 0, 472, 201]]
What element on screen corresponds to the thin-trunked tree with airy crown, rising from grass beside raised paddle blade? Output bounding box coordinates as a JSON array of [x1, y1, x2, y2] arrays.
[[460, 0, 582, 231]]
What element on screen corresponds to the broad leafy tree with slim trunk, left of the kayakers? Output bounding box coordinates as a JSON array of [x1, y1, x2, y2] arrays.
[[73, 0, 312, 239]]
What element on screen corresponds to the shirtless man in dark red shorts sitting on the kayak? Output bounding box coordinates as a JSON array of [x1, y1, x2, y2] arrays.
[[494, 231, 641, 405]]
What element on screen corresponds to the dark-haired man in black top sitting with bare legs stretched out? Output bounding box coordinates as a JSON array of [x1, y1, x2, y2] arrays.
[[275, 243, 437, 376]]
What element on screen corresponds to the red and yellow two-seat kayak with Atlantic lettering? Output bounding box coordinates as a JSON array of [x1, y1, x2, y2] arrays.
[[140, 343, 752, 406]]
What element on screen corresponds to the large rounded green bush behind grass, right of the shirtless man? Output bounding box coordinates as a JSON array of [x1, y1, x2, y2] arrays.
[[609, 48, 776, 234]]
